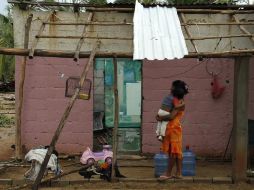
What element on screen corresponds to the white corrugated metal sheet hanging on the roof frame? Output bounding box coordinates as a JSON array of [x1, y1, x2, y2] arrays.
[[133, 2, 188, 60]]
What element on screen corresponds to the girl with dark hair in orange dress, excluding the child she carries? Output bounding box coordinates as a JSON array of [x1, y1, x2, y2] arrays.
[[157, 81, 188, 180]]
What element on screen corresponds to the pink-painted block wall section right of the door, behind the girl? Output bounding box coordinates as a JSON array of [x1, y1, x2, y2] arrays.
[[142, 59, 254, 156]]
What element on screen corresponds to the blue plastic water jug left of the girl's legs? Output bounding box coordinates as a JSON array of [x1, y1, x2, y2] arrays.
[[154, 152, 168, 177]]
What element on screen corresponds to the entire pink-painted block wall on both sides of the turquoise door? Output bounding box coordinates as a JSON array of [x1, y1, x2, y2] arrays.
[[16, 57, 254, 156]]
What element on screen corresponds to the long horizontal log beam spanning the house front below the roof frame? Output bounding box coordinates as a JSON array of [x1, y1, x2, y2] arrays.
[[0, 48, 254, 58]]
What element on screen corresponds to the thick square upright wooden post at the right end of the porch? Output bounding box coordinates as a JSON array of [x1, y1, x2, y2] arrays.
[[232, 57, 250, 182]]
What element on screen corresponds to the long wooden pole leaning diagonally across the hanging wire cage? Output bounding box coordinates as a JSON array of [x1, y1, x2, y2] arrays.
[[33, 42, 100, 190]]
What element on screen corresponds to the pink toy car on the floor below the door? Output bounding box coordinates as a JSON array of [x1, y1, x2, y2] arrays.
[[80, 145, 113, 164]]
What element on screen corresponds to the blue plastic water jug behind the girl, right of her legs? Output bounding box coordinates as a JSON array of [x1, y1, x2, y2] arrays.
[[182, 146, 196, 176]]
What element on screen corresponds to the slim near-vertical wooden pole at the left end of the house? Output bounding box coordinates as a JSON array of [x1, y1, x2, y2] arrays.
[[15, 14, 33, 159]]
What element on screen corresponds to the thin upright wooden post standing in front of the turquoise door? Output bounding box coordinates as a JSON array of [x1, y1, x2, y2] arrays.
[[112, 56, 119, 179]]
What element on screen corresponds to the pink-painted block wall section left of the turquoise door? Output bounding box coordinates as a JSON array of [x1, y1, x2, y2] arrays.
[[16, 57, 93, 153]]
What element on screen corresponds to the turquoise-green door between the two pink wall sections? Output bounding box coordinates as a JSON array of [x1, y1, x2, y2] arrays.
[[94, 59, 142, 153]]
